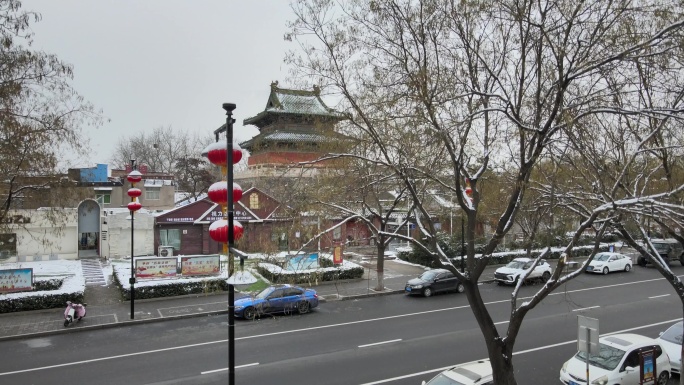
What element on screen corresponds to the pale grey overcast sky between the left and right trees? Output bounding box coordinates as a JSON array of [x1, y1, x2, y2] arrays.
[[22, 0, 294, 167]]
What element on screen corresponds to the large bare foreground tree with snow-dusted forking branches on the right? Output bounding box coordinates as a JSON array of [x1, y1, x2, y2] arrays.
[[286, 0, 684, 385]]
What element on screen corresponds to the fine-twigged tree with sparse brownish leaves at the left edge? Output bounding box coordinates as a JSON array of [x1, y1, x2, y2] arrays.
[[0, 0, 102, 224]]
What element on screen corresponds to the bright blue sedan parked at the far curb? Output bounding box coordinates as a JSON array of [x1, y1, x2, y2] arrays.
[[235, 285, 318, 320]]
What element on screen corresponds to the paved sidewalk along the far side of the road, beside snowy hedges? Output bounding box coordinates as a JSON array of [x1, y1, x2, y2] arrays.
[[0, 255, 588, 340]]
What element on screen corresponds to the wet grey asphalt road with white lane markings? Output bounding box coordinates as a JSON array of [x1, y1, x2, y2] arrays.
[[0, 266, 684, 385]]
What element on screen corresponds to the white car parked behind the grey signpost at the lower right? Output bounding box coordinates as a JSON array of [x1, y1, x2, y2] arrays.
[[560, 333, 671, 385]]
